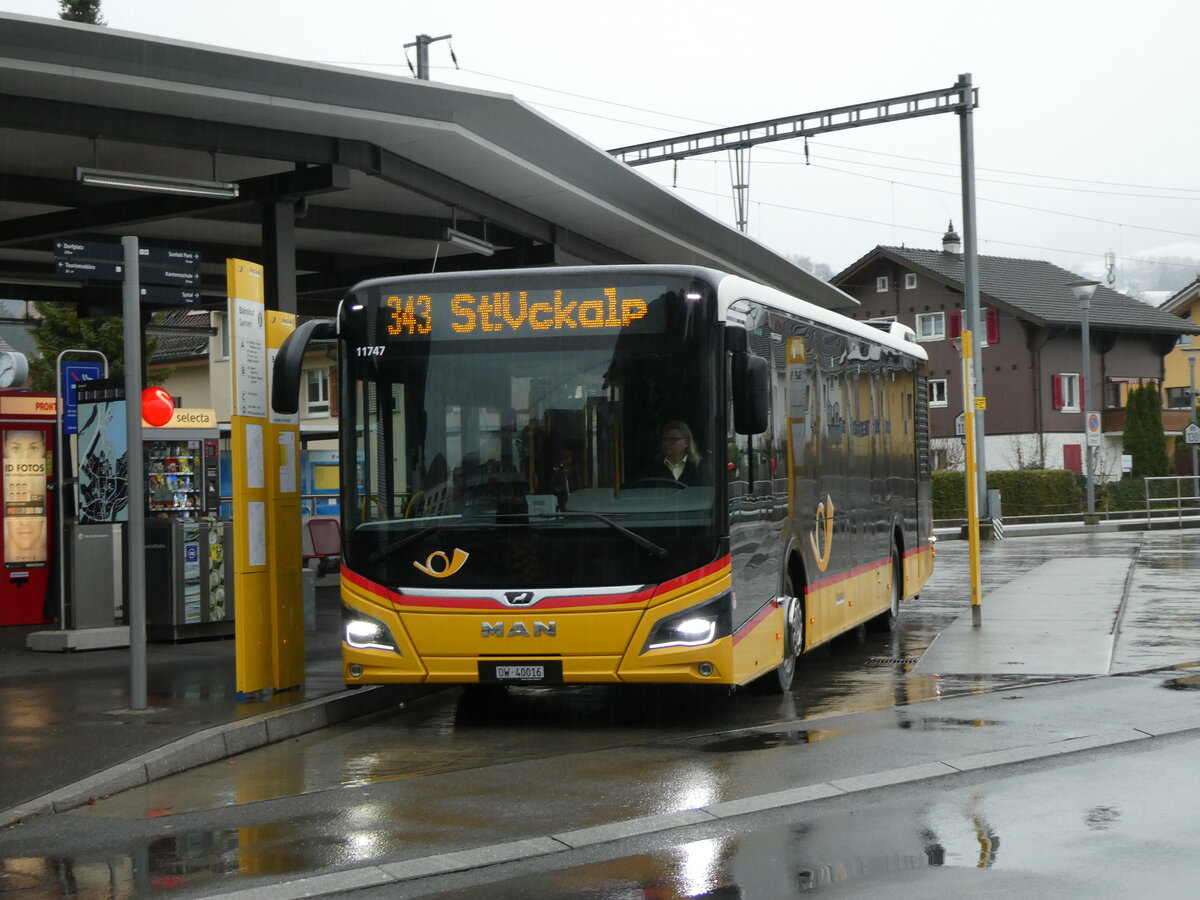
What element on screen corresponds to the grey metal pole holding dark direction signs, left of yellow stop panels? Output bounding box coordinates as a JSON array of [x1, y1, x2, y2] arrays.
[[121, 236, 146, 709]]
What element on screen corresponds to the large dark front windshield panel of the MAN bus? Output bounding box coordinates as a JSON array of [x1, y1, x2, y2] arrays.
[[342, 278, 725, 590]]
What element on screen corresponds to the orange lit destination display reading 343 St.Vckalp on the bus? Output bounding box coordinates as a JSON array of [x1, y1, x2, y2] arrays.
[[382, 287, 666, 340]]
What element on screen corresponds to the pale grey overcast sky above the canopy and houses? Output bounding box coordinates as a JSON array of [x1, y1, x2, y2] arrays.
[[7, 0, 1200, 296]]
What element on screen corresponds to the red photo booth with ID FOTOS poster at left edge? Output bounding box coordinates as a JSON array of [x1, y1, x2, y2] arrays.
[[0, 391, 58, 625]]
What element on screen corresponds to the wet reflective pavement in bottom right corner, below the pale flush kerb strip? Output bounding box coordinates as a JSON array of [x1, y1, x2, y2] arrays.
[[410, 738, 1200, 900]]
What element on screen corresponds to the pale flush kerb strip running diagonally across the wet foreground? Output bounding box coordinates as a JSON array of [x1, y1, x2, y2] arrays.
[[203, 716, 1200, 900]]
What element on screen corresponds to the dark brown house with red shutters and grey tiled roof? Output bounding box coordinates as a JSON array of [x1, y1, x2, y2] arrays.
[[830, 224, 1200, 481]]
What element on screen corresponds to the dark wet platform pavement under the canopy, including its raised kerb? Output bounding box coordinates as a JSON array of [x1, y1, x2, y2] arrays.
[[0, 576, 427, 827]]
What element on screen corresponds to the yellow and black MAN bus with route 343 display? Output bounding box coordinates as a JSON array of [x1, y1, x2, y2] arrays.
[[272, 265, 934, 691]]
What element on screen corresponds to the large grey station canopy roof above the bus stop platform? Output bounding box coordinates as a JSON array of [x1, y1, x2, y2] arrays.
[[0, 14, 853, 314]]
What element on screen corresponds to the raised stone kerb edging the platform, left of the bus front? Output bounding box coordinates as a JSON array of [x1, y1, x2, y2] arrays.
[[0, 684, 440, 828]]
